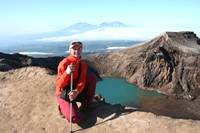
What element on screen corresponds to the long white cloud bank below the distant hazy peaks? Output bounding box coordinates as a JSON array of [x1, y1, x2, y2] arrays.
[[38, 27, 199, 42]]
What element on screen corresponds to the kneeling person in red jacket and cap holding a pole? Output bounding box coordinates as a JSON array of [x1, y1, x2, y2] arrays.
[[56, 41, 103, 123]]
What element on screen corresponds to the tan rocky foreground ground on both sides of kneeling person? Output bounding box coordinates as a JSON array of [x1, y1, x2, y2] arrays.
[[0, 67, 200, 133]]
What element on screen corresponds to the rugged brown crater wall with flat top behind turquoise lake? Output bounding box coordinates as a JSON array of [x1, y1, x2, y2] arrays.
[[88, 32, 200, 100]]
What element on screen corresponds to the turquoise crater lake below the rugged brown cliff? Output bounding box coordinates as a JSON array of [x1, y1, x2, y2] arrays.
[[96, 77, 161, 106]]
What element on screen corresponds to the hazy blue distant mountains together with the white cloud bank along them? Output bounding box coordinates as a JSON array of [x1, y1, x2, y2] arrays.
[[0, 21, 200, 44]]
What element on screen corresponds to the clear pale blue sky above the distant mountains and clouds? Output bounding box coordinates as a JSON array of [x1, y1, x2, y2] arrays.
[[0, 0, 200, 37]]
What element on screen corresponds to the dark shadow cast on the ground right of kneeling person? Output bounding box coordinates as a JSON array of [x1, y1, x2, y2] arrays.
[[74, 102, 138, 131]]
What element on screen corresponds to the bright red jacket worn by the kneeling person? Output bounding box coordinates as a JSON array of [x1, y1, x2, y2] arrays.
[[56, 55, 87, 96]]
